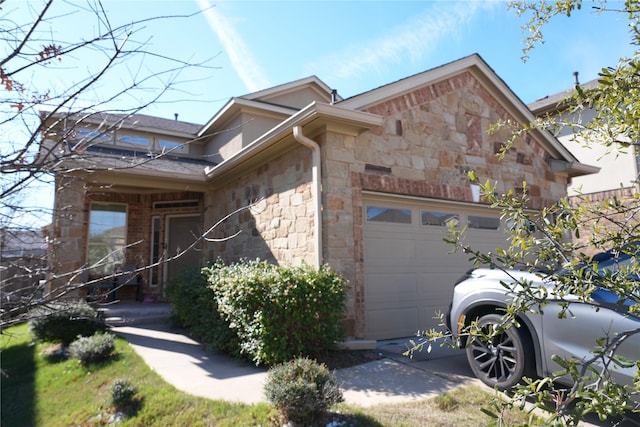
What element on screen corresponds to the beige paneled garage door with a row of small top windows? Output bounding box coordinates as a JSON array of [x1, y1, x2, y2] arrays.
[[364, 196, 507, 339]]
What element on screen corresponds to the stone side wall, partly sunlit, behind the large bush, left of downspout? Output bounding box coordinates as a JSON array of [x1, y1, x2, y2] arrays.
[[205, 146, 316, 265]]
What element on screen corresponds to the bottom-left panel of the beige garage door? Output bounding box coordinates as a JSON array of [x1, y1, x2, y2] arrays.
[[365, 307, 420, 338]]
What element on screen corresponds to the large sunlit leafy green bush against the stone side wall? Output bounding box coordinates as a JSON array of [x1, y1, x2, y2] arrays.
[[203, 260, 347, 365]]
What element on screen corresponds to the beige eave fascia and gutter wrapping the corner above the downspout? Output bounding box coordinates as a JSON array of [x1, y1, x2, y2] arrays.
[[205, 102, 383, 179]]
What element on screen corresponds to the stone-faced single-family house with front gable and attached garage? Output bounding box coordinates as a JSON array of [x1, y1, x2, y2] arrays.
[[43, 55, 597, 339]]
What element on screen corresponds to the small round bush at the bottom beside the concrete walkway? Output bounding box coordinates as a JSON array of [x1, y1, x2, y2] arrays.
[[264, 358, 343, 426]]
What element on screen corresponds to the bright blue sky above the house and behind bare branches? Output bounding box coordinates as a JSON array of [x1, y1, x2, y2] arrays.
[[3, 0, 634, 227]]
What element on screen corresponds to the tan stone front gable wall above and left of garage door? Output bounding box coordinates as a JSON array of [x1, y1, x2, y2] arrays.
[[322, 73, 567, 337]]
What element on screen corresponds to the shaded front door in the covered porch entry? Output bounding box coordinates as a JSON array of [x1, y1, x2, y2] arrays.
[[164, 215, 202, 283]]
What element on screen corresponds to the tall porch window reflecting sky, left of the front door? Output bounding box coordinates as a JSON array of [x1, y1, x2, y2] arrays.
[[87, 203, 127, 276]]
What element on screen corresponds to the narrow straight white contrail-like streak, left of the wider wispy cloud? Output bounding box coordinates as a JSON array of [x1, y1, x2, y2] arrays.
[[196, 0, 271, 92]]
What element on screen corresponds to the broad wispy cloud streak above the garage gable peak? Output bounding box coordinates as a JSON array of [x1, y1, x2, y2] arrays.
[[308, 1, 501, 79]]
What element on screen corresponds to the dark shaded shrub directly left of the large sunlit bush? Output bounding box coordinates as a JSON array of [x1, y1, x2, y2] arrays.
[[166, 270, 239, 355]]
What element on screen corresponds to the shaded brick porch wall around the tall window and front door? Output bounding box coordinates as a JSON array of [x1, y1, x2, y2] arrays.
[[49, 176, 203, 299]]
